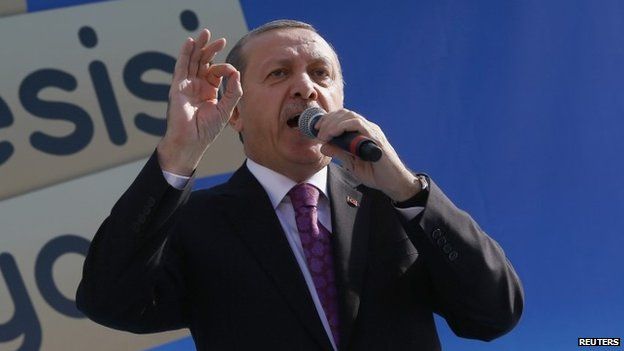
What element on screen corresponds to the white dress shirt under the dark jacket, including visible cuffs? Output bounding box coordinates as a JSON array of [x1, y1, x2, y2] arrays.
[[163, 158, 423, 350]]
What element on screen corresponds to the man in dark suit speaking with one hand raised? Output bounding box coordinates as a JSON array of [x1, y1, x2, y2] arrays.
[[77, 21, 523, 350]]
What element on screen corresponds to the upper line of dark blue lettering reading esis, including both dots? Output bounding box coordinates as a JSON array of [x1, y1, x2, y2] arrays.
[[0, 10, 199, 166]]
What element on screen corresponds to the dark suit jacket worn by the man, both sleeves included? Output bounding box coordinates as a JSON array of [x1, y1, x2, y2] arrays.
[[76, 156, 523, 350]]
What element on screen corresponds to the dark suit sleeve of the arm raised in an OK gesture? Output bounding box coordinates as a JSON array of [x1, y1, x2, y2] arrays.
[[76, 153, 192, 333]]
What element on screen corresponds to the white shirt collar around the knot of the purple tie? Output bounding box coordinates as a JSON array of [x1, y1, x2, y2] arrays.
[[247, 158, 329, 209]]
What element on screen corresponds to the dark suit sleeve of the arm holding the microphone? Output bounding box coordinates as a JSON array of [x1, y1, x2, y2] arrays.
[[405, 181, 524, 340]]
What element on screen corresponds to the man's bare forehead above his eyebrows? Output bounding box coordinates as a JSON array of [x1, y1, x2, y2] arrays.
[[243, 28, 338, 68]]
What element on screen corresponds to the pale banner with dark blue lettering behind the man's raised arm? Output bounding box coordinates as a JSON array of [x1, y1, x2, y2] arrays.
[[0, 0, 247, 351]]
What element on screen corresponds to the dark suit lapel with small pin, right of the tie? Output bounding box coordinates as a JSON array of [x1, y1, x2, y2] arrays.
[[328, 164, 370, 349]]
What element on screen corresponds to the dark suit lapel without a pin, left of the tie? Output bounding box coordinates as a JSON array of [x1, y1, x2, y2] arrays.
[[225, 165, 332, 350]]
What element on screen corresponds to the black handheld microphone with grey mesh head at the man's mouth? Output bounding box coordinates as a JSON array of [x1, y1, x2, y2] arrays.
[[299, 107, 382, 162]]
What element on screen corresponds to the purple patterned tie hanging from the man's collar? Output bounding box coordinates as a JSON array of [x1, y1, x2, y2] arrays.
[[288, 183, 339, 346]]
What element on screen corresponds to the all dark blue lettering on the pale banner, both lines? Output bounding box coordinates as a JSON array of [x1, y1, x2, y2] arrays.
[[0, 6, 204, 351]]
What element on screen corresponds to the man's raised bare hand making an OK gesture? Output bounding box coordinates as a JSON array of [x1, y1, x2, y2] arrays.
[[157, 29, 243, 175]]
